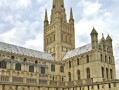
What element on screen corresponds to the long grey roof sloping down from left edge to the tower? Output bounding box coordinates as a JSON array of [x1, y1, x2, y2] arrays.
[[0, 42, 54, 60]]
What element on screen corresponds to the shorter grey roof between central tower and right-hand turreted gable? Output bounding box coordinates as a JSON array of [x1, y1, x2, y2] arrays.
[[62, 43, 92, 60]]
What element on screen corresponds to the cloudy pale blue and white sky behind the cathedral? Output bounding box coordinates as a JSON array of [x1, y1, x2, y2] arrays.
[[0, 0, 119, 78]]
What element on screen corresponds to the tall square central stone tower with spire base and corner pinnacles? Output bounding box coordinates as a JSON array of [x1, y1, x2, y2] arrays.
[[44, 0, 75, 61]]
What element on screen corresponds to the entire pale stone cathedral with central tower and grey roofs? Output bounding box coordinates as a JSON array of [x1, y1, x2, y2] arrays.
[[0, 0, 119, 90]]
